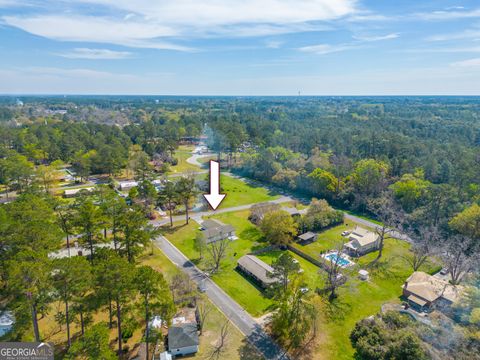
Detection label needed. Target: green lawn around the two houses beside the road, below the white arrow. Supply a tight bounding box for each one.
[161,211,272,316]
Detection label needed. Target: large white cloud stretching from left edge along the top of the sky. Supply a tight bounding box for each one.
[0,0,357,51]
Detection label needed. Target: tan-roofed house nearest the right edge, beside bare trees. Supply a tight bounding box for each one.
[402,271,462,311]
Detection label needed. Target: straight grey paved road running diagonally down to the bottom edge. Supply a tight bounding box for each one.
[154,236,288,360]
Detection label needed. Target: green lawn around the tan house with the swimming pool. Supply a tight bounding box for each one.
[260,223,440,359]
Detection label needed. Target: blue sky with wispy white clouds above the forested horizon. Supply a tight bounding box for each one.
[0,0,480,95]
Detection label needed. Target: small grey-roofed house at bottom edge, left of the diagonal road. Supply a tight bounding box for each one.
[168,323,200,356]
